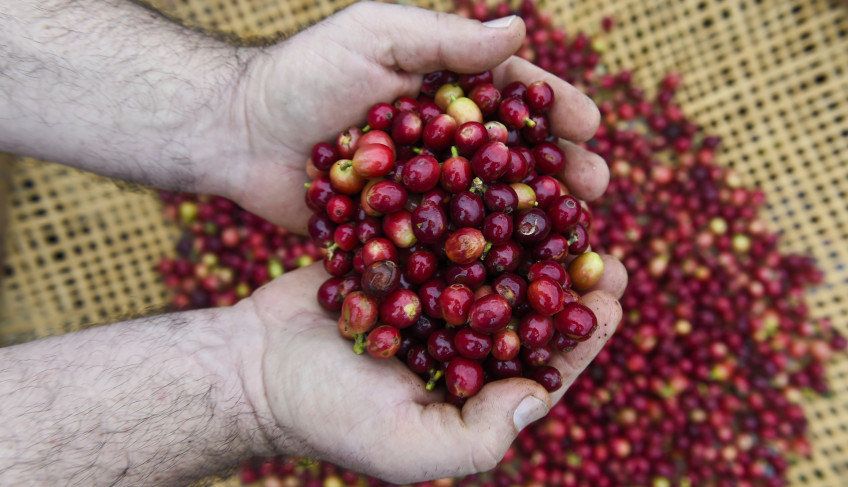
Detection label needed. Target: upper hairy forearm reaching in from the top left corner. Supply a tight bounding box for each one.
[0,0,243,192]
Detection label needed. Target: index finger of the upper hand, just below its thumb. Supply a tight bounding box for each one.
[494,56,601,142]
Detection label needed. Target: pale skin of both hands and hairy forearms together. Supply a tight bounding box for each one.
[0,0,627,485]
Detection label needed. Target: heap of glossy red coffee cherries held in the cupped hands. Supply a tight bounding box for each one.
[306,71,603,405]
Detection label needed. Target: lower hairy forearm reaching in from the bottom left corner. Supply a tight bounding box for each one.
[0,308,266,486]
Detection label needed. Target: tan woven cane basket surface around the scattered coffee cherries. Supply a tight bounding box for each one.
[0,0,848,487]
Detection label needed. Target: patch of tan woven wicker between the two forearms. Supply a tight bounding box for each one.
[0,159,176,345]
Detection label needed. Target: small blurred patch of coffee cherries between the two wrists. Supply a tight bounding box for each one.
[156,191,324,310]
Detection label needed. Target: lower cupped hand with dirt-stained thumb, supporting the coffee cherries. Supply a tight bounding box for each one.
[237,169,627,483]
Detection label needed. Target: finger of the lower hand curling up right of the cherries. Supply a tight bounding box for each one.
[551,291,622,402]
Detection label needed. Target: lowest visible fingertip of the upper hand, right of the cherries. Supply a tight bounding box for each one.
[559,140,610,201]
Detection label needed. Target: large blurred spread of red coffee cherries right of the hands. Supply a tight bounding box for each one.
[157,0,846,487]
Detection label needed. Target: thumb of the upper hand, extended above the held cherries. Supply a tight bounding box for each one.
[335,2,525,73]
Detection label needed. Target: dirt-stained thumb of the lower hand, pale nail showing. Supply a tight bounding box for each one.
[381,378,552,484]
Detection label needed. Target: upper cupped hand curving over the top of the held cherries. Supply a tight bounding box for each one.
[215,2,606,233]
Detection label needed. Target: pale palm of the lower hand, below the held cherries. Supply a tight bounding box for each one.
[245,265,490,475]
